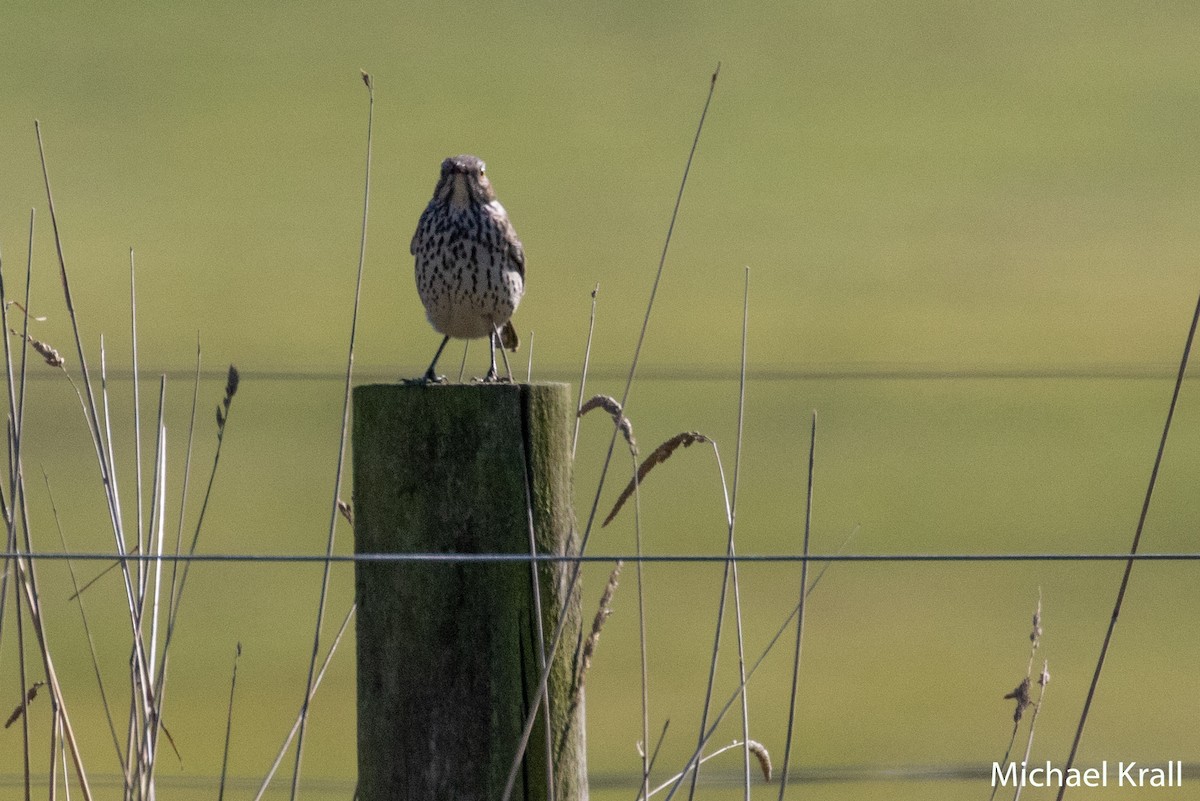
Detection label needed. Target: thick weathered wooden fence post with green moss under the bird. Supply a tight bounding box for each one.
[354,384,587,801]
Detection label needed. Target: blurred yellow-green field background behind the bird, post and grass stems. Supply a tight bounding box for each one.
[0,2,1200,799]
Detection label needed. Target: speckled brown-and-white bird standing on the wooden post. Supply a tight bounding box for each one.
[409,155,524,384]
